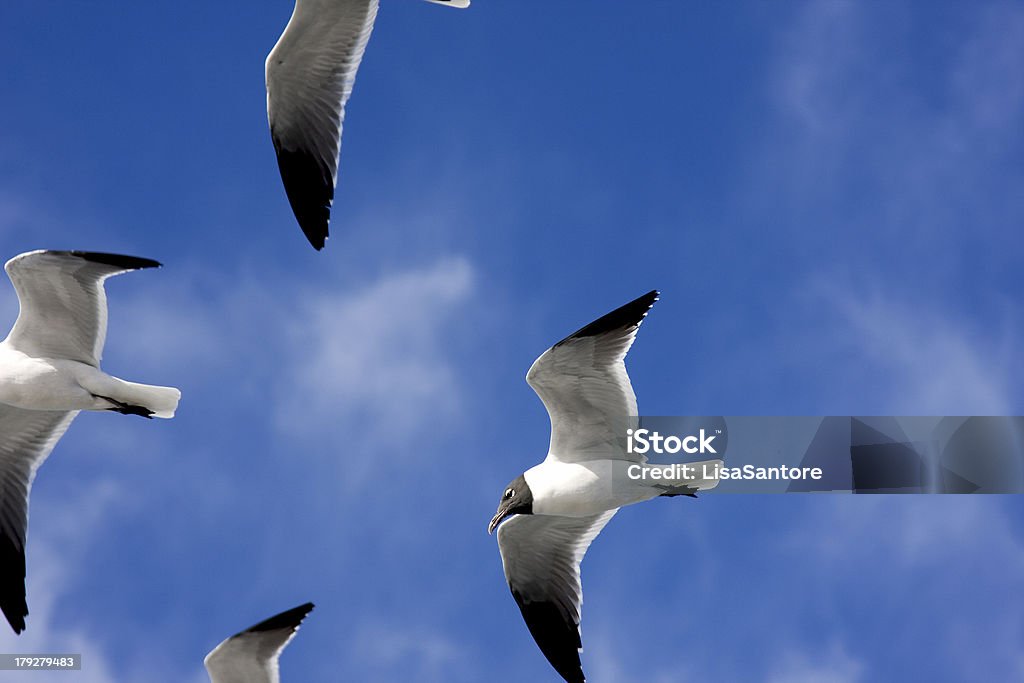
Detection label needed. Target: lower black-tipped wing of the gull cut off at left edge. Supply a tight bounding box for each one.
[0,403,78,633]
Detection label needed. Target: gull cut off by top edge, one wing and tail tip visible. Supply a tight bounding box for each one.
[266,0,469,251]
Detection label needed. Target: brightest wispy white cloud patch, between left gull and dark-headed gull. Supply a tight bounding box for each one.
[278,258,473,438]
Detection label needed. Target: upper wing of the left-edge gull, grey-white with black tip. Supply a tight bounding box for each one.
[4,250,160,367]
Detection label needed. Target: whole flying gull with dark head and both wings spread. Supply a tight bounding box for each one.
[487,291,720,683]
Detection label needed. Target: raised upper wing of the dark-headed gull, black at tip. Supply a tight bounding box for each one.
[526,291,658,462]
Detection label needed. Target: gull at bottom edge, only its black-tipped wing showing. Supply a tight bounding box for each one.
[203,602,313,683]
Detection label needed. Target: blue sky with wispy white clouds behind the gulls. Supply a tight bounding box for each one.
[0,0,1024,683]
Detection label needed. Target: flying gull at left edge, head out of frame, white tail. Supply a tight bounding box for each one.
[0,251,181,633]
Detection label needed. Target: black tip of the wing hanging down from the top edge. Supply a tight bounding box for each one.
[273,143,334,251]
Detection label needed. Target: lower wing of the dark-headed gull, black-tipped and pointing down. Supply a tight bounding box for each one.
[498,510,616,683]
